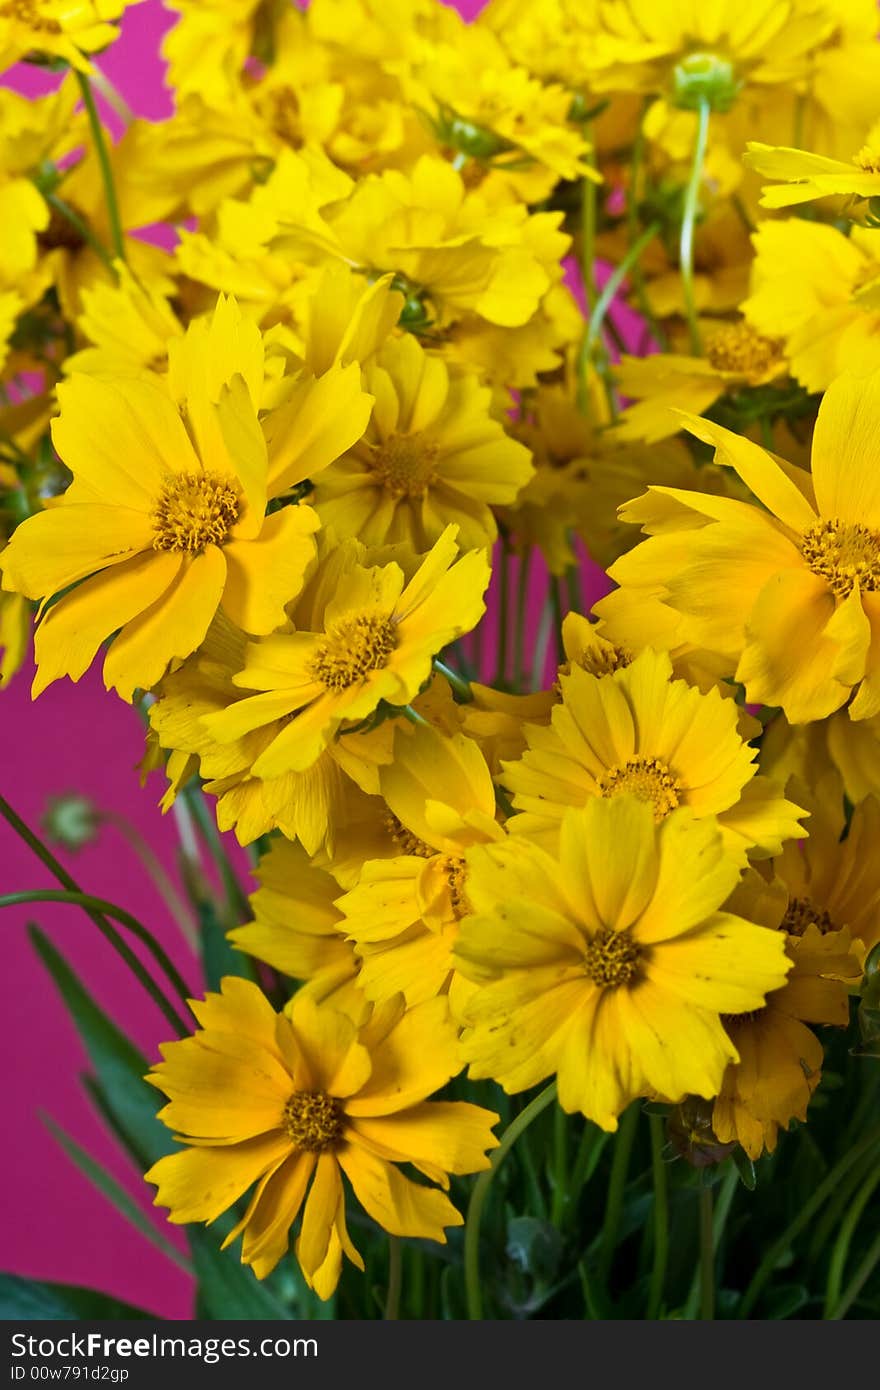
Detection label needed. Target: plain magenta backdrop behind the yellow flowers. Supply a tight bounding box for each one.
[0,0,611,1318]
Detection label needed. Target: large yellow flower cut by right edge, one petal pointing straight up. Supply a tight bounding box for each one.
[596,373,880,723]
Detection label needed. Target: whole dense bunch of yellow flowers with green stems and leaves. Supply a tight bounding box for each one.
[0,0,880,1319]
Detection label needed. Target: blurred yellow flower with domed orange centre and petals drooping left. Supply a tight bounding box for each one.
[612,320,787,443]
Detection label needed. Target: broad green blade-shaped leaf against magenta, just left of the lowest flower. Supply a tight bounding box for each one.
[29,926,174,1168]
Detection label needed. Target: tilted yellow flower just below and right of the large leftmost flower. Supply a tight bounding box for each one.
[204,527,489,777]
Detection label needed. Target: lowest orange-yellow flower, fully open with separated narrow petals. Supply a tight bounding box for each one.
[146,977,498,1298]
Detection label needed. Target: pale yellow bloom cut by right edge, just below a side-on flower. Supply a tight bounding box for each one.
[742,217,880,391]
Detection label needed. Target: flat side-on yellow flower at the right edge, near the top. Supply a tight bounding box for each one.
[744,122,880,207]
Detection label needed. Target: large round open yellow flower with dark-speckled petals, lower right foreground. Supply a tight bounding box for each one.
[456,796,791,1130]
